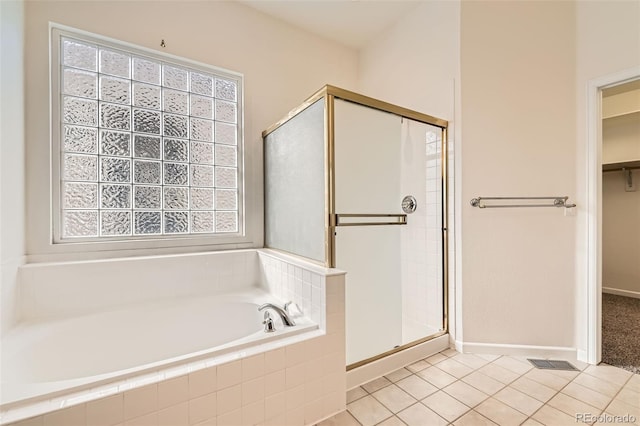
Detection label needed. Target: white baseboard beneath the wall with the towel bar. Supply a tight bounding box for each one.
[456,341,578,361]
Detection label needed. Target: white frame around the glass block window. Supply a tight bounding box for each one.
[49,23,254,252]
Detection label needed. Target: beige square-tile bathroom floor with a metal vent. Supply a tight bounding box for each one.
[318,349,640,426]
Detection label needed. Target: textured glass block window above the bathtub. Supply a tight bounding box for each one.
[54,32,242,241]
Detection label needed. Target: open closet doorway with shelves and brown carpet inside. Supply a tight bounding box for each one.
[600,79,640,373]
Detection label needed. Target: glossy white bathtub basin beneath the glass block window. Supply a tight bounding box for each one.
[2,289,317,405]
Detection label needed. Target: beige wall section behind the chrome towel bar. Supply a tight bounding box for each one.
[460,2,576,348]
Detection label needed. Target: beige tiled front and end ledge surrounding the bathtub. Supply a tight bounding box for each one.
[2,250,346,426]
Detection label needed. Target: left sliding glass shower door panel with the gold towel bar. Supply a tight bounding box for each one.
[334,100,402,365]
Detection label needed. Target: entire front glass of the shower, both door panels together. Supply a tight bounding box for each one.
[334,100,444,365]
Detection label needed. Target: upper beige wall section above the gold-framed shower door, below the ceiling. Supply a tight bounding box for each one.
[358,2,460,128]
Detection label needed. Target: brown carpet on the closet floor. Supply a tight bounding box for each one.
[602,293,640,374]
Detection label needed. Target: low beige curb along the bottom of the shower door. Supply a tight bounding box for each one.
[347,334,449,389]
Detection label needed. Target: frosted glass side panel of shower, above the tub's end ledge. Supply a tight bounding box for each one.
[264,99,325,263]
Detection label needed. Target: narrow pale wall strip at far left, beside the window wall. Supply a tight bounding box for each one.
[0,1,25,338]
